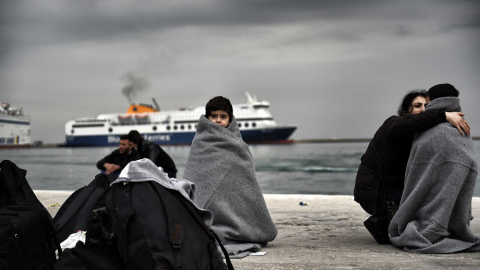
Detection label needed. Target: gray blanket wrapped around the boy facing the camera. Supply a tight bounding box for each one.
[184,115,277,258]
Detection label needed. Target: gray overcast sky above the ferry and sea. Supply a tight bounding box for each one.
[0,0,480,143]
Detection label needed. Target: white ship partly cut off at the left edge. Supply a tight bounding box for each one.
[0,102,30,148]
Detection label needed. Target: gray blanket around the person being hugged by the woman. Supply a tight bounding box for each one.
[389,97,480,253]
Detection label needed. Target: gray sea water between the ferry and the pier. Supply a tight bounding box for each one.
[0,141,480,197]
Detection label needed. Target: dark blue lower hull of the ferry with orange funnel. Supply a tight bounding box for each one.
[65,127,296,147]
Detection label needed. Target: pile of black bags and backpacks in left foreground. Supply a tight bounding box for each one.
[0,161,233,270]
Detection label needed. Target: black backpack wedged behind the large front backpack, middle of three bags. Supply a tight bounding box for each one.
[54,174,125,270]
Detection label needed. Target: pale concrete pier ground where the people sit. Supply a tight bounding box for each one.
[35,190,480,270]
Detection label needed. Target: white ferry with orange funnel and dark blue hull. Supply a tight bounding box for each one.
[65,93,297,146]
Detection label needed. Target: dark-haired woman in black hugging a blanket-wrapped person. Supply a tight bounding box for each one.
[353,90,470,244]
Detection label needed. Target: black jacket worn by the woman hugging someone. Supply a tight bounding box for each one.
[353,109,446,213]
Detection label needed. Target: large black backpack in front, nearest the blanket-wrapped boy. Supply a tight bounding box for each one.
[105,181,233,270]
